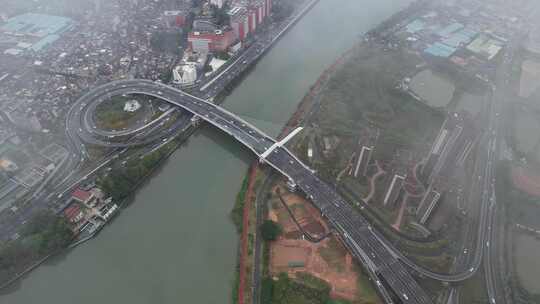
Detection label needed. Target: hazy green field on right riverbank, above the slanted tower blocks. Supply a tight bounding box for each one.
[298,45,444,184]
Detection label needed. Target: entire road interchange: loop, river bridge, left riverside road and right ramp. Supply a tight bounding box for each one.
[1,1,520,304]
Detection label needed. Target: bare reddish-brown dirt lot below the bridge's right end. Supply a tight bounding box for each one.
[269,185,375,303]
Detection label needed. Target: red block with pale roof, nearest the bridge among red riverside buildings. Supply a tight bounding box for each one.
[188,29,235,53]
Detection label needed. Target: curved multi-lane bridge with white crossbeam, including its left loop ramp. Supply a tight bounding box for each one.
[66,80,464,304]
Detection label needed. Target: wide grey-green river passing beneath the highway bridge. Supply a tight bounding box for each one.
[0,0,411,304]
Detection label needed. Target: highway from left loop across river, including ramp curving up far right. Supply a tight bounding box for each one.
[67,75,524,303]
